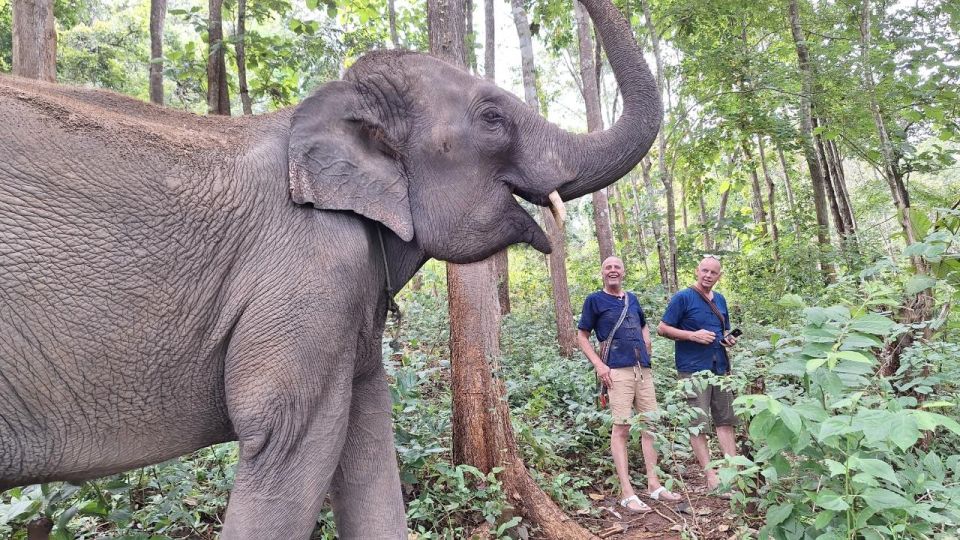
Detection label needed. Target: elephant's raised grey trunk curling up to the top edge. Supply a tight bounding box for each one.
[557,0,663,200]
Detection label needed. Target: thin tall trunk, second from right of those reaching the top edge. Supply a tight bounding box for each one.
[789,0,836,283]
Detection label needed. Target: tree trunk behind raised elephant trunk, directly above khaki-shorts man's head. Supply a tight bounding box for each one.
[573,2,613,260]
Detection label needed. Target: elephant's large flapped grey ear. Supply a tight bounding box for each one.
[288,81,413,242]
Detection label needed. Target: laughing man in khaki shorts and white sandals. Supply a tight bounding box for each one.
[577,257,680,512]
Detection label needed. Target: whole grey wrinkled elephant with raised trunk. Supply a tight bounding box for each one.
[0,0,661,538]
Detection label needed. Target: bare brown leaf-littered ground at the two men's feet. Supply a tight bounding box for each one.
[573,467,755,540]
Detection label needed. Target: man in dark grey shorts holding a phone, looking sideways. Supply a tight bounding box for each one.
[657,255,737,496]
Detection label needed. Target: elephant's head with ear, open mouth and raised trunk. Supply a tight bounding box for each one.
[289,0,663,262]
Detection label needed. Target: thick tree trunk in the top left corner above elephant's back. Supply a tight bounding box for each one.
[11,0,57,82]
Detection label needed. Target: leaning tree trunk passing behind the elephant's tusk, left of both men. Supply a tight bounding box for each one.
[510,0,577,358]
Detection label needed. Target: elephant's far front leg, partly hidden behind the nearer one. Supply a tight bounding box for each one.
[331,366,407,539]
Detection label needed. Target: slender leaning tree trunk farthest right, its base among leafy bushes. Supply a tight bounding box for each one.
[860,0,933,376]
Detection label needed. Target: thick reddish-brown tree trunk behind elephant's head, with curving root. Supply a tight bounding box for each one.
[444,0,594,539]
